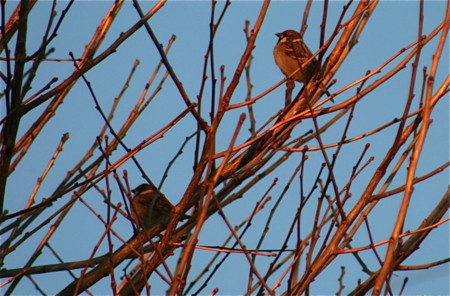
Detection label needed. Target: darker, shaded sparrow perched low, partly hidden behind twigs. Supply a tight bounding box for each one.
[131,183,189,229]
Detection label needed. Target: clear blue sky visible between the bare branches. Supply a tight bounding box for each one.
[1,1,450,295]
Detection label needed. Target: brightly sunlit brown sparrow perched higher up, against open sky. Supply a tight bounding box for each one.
[273,30,330,95]
